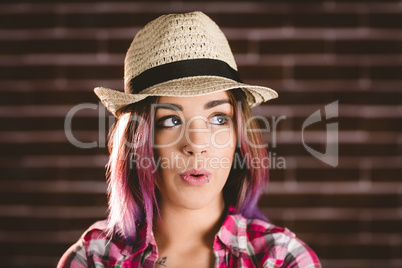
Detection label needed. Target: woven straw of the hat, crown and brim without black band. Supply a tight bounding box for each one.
[95,12,278,116]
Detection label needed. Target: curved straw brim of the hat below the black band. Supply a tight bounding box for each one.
[94,76,278,116]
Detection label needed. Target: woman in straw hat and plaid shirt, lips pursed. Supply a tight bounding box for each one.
[58,12,321,267]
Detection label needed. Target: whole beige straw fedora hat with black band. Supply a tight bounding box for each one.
[94,11,278,116]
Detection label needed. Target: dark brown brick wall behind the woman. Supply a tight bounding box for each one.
[0,0,402,268]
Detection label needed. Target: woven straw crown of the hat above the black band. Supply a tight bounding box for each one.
[124,12,237,88]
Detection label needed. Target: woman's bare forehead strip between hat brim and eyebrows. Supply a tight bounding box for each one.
[158,91,229,106]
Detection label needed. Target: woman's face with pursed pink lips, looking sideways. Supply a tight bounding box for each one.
[154,92,236,209]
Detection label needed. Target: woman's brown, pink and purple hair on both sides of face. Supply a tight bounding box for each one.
[107,89,268,239]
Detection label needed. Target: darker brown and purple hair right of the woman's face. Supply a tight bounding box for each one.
[223,89,269,220]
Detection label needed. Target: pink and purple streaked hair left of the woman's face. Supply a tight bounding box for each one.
[107,98,158,238]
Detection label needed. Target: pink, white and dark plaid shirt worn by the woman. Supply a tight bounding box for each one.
[57,210,321,268]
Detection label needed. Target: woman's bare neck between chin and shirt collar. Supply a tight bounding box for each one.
[154,197,225,248]
